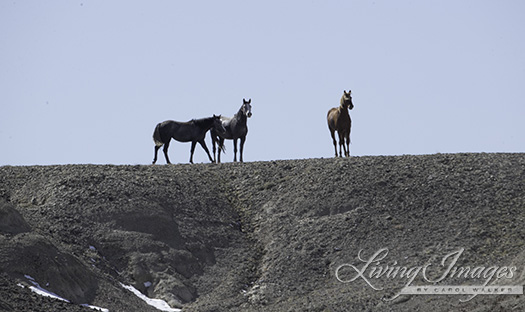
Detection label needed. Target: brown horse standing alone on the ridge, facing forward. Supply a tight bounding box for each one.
[326,90,354,157]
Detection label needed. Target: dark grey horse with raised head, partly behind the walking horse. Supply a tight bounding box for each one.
[210,99,252,163]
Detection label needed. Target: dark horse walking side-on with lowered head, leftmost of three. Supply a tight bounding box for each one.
[153,115,224,164]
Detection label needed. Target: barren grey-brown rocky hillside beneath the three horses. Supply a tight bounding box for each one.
[0,154,525,311]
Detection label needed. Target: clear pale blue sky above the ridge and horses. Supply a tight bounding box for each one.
[0,0,525,165]
